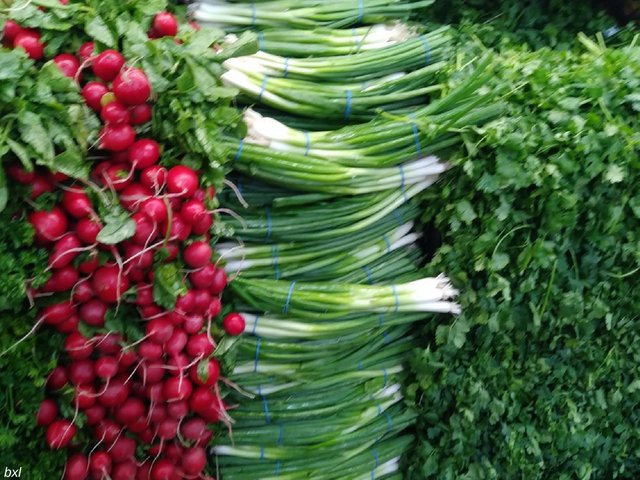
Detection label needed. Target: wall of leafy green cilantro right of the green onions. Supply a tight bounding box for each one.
[406,5,640,480]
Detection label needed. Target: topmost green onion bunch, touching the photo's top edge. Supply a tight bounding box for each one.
[189,0,434,30]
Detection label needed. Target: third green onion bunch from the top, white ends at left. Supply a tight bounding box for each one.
[223,27,450,82]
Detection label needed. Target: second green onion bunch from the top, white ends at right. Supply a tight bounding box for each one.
[244,22,418,57]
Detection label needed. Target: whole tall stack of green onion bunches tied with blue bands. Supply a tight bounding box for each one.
[192,1,499,480]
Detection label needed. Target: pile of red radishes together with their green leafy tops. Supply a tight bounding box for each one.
[0,2,252,480]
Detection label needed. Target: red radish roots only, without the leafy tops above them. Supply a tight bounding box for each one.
[4,7,245,480]
